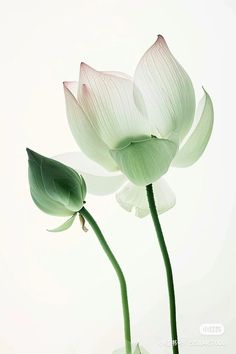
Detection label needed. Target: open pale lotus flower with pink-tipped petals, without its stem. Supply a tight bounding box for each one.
[56,35,214,217]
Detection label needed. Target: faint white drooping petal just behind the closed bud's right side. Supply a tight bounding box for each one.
[54,152,126,195]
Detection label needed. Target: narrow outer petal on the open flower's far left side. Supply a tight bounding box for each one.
[64,82,117,171]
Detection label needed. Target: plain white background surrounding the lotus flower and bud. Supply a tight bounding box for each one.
[0,0,236,354]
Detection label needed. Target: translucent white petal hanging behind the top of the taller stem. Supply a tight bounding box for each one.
[116,178,176,218]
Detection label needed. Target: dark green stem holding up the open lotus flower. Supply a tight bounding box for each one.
[146,184,179,354]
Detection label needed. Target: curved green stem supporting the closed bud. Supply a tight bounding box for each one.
[79,207,132,354]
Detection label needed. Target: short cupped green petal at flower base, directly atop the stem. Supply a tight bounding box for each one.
[110,137,177,186]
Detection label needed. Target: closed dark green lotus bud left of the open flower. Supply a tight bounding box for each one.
[27,149,86,217]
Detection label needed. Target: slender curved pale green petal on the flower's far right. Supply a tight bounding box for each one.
[172,91,214,167]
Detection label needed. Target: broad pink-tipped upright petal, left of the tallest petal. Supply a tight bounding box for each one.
[78,63,150,148]
